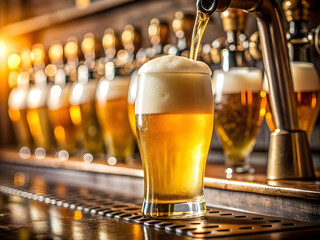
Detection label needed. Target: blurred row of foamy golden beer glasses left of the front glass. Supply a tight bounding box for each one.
[8,30,138,161]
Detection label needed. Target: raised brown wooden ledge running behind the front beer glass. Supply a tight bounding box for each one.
[0,149,320,200]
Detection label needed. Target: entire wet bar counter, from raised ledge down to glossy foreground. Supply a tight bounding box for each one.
[0,149,320,239]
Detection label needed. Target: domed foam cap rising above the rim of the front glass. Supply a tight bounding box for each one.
[139,55,212,75]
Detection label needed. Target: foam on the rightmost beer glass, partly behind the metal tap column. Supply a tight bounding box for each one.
[263,62,320,92]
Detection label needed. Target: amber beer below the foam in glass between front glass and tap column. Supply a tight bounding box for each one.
[215,91,264,164]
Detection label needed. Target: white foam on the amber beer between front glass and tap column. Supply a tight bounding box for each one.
[213,68,262,94]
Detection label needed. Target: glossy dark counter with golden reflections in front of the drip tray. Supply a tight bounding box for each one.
[0,195,162,240]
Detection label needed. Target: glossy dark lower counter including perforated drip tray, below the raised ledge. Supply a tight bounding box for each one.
[0,164,320,240]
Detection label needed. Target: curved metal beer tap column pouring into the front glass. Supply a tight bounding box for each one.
[197,0,314,180]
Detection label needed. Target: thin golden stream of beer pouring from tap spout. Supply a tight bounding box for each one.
[189,11,210,60]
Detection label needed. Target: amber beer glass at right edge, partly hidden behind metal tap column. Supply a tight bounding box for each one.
[263,62,320,138]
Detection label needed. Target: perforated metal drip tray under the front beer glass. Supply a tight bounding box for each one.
[0,183,320,238]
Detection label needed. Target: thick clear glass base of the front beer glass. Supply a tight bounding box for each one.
[142,201,207,219]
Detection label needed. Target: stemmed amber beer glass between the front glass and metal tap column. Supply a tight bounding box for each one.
[213,67,265,174]
